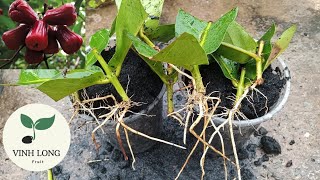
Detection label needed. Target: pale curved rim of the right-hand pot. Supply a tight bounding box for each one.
[212,58,291,127]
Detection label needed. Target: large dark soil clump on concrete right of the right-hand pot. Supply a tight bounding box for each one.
[261,136,281,155]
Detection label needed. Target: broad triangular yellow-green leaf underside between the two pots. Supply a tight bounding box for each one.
[151,33,209,67]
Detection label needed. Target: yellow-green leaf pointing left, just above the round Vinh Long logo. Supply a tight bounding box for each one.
[37,66,105,101]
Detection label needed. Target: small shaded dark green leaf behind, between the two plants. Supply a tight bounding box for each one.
[146,24,175,42]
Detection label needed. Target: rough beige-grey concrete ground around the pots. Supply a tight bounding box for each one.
[0,0,320,180]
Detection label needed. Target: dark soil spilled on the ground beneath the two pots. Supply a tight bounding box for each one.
[53,115,257,180]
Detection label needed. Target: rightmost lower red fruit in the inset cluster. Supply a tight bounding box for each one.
[57,26,82,54]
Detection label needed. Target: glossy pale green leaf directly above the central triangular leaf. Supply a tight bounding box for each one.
[175,9,208,41]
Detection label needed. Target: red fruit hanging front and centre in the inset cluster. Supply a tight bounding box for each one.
[26,20,48,51]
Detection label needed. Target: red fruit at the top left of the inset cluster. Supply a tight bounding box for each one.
[9,0,38,25]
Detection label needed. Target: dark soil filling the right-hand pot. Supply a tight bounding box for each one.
[200,63,286,119]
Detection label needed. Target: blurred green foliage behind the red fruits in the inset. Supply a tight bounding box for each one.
[0,0,86,69]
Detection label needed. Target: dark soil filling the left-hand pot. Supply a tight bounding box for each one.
[81,47,163,115]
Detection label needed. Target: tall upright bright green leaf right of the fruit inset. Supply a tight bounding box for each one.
[109,0,148,68]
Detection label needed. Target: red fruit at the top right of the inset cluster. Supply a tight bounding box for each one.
[43,4,77,26]
